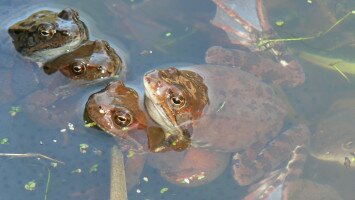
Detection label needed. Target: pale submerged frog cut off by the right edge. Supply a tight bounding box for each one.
[310,99,355,168]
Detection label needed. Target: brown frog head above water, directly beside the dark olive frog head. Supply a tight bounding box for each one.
[43,40,126,81]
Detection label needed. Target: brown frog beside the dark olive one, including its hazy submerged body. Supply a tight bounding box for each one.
[22,40,126,127]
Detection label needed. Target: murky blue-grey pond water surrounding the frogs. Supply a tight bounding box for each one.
[0,0,355,200]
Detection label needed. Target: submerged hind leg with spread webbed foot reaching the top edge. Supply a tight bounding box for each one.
[206,0,305,87]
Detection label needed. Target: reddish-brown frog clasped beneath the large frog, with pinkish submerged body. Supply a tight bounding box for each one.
[86,82,229,189]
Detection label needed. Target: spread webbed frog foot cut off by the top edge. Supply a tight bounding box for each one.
[211,0,292,66]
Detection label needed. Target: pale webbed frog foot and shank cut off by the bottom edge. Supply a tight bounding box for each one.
[244,145,308,200]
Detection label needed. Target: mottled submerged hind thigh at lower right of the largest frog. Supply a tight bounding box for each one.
[233,124,310,185]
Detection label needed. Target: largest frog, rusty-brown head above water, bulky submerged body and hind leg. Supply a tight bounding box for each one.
[143,64,310,197]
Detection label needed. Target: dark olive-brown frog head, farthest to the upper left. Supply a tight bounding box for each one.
[8,8,89,62]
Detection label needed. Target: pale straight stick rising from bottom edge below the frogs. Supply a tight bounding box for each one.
[110,146,128,200]
